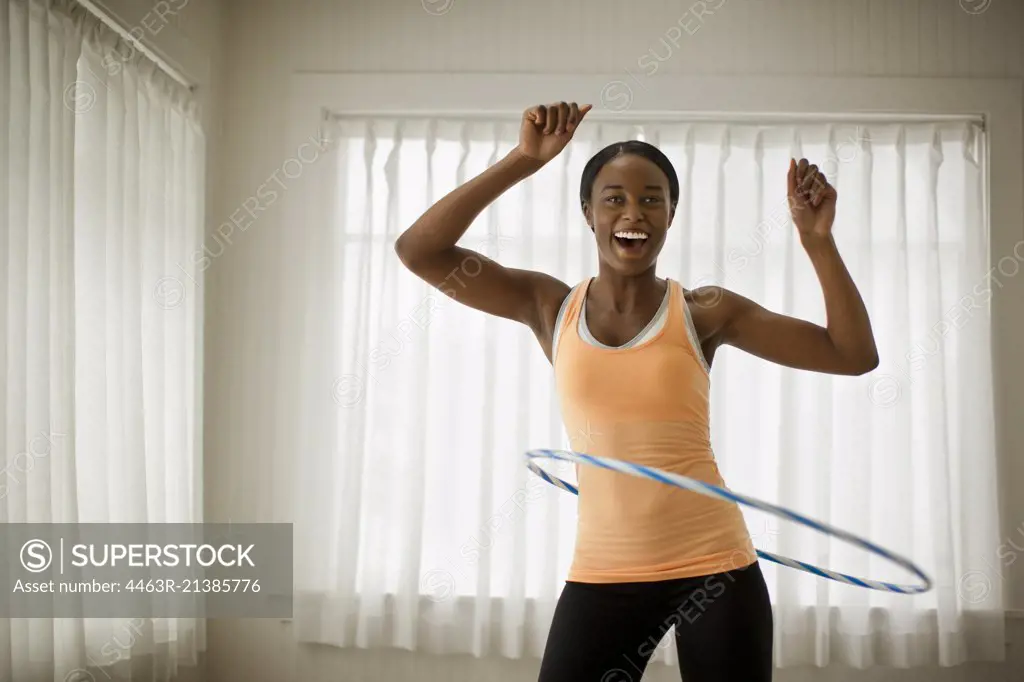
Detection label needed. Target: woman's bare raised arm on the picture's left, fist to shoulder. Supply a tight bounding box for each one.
[394,102,591,354]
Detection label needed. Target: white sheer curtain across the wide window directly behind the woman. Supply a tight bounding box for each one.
[290,117,1007,667]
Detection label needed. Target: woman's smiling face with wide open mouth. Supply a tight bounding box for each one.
[584,154,673,274]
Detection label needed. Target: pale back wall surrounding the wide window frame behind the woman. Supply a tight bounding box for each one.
[205,0,1024,682]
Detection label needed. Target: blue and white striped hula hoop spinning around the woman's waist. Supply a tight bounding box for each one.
[526,450,932,594]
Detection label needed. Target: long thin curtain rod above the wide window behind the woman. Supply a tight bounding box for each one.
[323,109,985,130]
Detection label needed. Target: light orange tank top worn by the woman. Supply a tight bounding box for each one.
[554,279,757,583]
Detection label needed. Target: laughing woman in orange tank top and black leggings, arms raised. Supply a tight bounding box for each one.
[395,102,878,682]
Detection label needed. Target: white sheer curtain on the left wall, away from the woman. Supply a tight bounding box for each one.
[0,0,205,682]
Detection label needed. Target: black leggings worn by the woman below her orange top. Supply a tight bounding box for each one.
[538,562,772,682]
